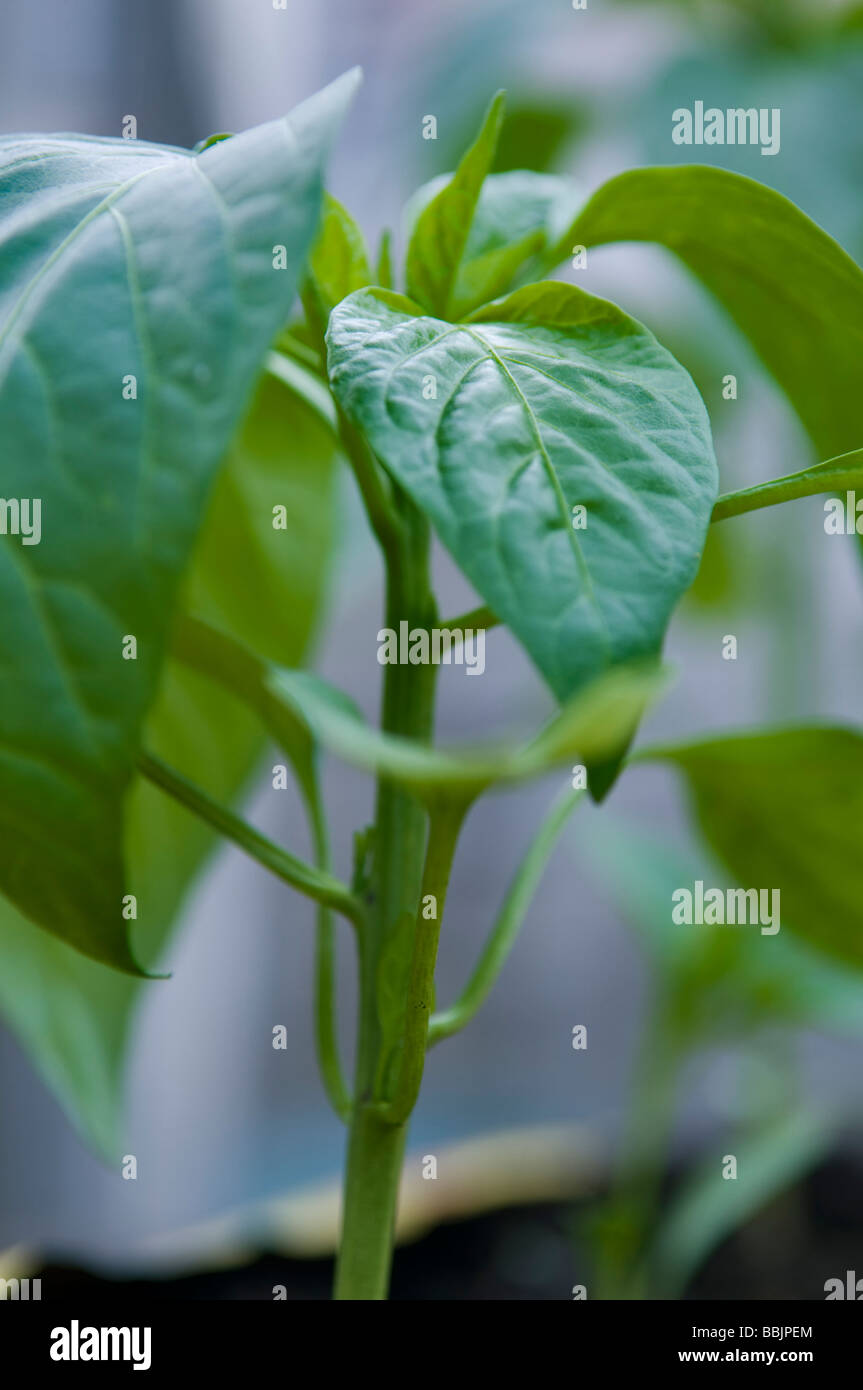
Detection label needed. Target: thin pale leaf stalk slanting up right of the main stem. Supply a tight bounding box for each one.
[428,788,585,1047]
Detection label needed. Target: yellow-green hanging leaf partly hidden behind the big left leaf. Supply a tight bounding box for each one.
[0,378,340,1154]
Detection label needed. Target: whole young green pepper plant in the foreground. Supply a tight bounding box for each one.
[0,74,863,1298]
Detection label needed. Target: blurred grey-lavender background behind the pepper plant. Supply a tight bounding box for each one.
[0,0,863,1298]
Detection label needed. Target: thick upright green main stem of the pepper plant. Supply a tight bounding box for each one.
[335,493,436,1300]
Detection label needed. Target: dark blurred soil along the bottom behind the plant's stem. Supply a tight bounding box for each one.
[30,1158,863,1302]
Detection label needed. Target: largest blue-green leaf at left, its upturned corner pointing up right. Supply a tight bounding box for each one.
[0,76,354,973]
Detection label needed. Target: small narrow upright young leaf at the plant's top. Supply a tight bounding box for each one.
[404,92,503,318]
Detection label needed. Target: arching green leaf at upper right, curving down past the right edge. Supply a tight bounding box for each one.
[559,164,863,456]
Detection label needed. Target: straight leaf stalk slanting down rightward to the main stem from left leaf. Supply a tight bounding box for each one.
[138,753,363,926]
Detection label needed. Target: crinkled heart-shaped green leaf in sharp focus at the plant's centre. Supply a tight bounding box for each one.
[328,281,716,699]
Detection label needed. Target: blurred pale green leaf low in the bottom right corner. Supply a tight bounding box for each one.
[648,1109,835,1298]
